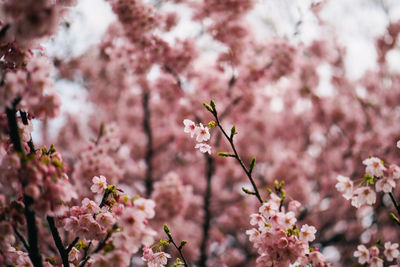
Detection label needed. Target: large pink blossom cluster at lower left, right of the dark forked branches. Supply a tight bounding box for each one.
[61,176,156,266]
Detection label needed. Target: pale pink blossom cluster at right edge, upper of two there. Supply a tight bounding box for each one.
[336,157,400,208]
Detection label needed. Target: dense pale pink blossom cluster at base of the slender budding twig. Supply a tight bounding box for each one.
[246,193,327,267]
